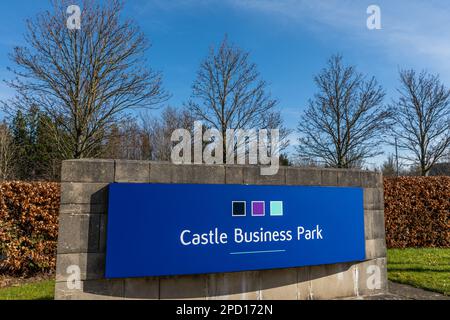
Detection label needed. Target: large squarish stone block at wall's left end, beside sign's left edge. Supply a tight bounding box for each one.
[58,214,101,253]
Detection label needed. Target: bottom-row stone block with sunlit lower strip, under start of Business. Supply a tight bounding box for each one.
[208,271,260,300]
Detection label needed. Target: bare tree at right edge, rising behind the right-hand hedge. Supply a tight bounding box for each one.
[392,70,450,176]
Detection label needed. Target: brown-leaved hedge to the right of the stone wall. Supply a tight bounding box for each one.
[384,177,450,248]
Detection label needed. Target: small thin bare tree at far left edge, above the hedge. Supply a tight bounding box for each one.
[0,123,17,181]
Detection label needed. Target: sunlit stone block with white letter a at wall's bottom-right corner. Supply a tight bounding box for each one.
[356,258,388,296]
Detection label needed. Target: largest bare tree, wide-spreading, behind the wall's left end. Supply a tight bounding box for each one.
[4,0,167,158]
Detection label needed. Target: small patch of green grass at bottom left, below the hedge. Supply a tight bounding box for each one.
[0,280,55,300]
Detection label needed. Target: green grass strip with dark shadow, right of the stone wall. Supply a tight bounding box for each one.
[388,248,450,295]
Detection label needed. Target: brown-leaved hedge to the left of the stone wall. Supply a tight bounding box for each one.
[0,182,60,276]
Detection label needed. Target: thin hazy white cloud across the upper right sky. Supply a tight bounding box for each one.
[229,0,450,80]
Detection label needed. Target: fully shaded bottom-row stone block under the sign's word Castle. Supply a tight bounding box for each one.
[159,275,207,300]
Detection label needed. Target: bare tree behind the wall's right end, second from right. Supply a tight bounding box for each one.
[297,55,389,168]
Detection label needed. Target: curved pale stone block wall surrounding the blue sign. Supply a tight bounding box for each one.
[55,160,387,300]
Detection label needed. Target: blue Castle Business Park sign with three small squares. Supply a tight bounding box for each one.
[106,183,365,278]
